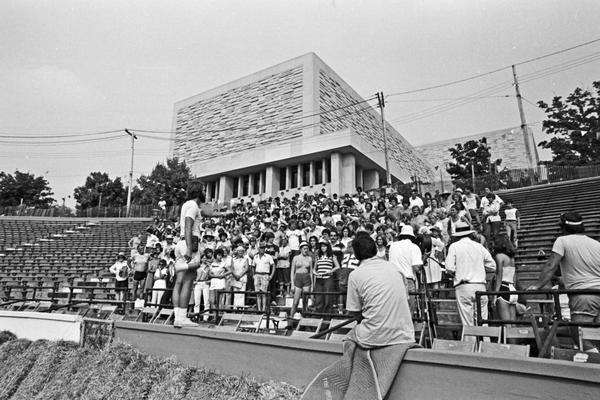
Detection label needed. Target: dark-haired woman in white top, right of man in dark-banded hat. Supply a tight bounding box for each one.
[494,235,518,328]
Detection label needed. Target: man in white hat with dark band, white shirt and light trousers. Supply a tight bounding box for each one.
[446,221,496,326]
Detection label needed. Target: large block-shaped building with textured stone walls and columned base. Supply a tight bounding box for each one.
[173,53,433,202]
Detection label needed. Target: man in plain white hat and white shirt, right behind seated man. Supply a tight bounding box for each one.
[389,225,423,314]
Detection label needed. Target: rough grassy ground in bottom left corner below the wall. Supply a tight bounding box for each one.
[0,332,300,400]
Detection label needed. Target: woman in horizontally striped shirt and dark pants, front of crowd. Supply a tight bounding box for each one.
[314,239,340,313]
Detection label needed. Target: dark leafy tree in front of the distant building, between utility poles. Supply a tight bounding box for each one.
[446,137,502,180]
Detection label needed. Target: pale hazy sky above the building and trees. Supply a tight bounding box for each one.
[0,0,600,206]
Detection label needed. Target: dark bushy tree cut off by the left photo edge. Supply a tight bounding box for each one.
[0,171,54,208]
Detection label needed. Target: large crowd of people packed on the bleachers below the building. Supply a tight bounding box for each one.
[111,180,520,324]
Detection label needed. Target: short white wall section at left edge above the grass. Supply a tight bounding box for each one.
[0,310,81,342]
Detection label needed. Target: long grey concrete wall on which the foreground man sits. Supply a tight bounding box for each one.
[115,321,600,400]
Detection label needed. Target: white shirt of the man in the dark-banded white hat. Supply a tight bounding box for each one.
[446,238,496,286]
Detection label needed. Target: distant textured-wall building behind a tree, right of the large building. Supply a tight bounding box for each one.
[415,127,539,180]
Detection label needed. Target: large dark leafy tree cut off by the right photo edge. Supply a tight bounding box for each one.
[538,81,600,165]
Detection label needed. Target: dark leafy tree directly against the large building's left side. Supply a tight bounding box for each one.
[132,157,193,205]
